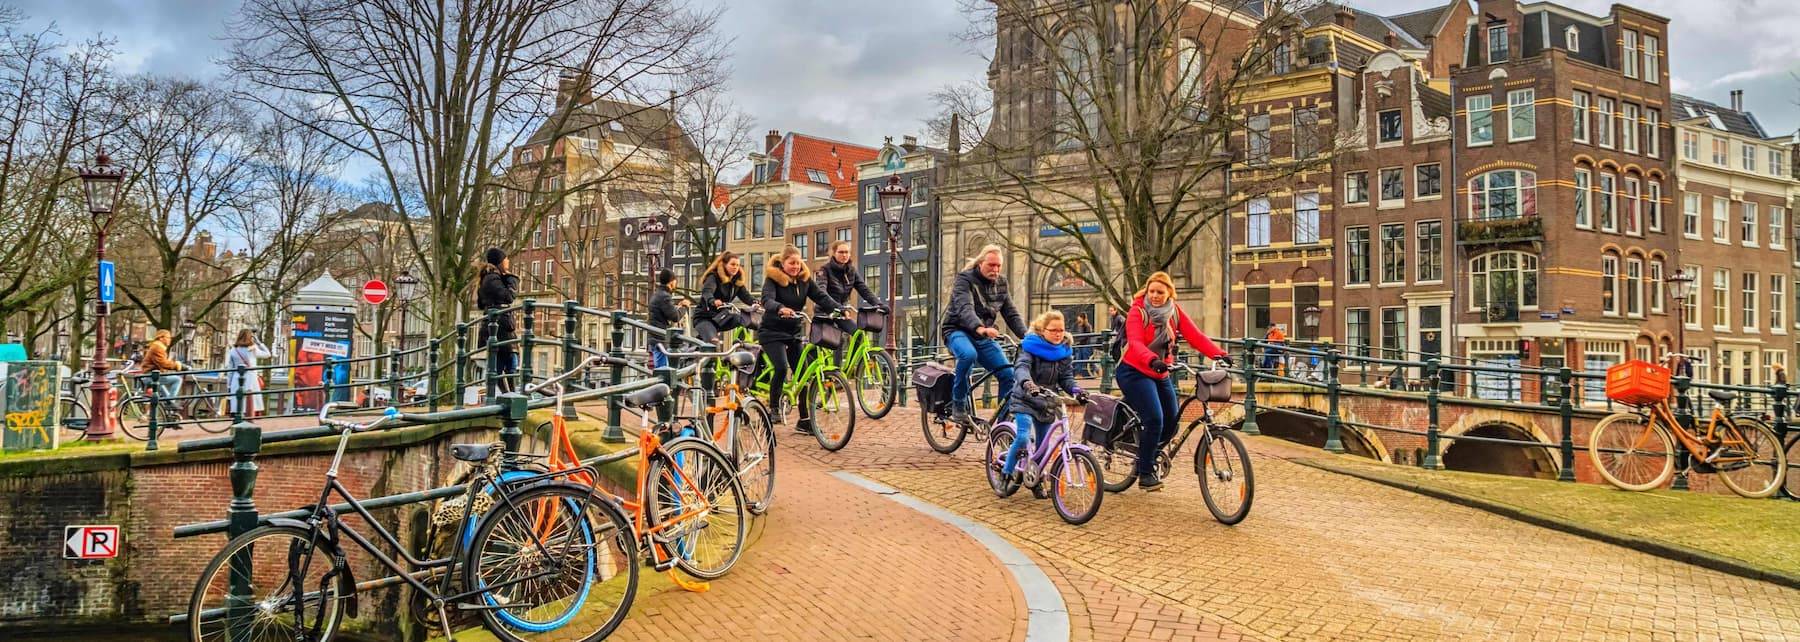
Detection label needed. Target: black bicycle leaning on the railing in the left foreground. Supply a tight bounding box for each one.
[184,403,637,642]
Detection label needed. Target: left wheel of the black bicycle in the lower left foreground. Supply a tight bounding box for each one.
[187,527,356,642]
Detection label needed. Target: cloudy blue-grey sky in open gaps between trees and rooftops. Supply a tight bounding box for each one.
[14,0,1800,152]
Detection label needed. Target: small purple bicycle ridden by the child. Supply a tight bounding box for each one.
[986,388,1105,525]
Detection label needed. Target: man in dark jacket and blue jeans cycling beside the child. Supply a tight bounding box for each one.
[943,245,1026,424]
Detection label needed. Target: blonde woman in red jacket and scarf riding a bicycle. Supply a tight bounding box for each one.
[1114,272,1229,491]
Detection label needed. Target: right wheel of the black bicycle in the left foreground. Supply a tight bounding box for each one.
[463,484,637,642]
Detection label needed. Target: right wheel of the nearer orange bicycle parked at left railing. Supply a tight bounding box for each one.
[643,439,751,579]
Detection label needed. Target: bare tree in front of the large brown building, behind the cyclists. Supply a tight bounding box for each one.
[927,0,1332,308]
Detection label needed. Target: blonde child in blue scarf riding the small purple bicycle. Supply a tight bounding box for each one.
[1001,311,1087,475]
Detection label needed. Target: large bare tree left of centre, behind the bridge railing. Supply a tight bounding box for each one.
[227,0,718,333]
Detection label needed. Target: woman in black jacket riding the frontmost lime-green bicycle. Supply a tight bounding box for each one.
[756,245,839,433]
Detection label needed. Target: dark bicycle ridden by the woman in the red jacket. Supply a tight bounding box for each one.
[1098,361,1256,525]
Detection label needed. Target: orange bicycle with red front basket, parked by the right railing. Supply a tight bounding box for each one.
[1588,361,1787,498]
